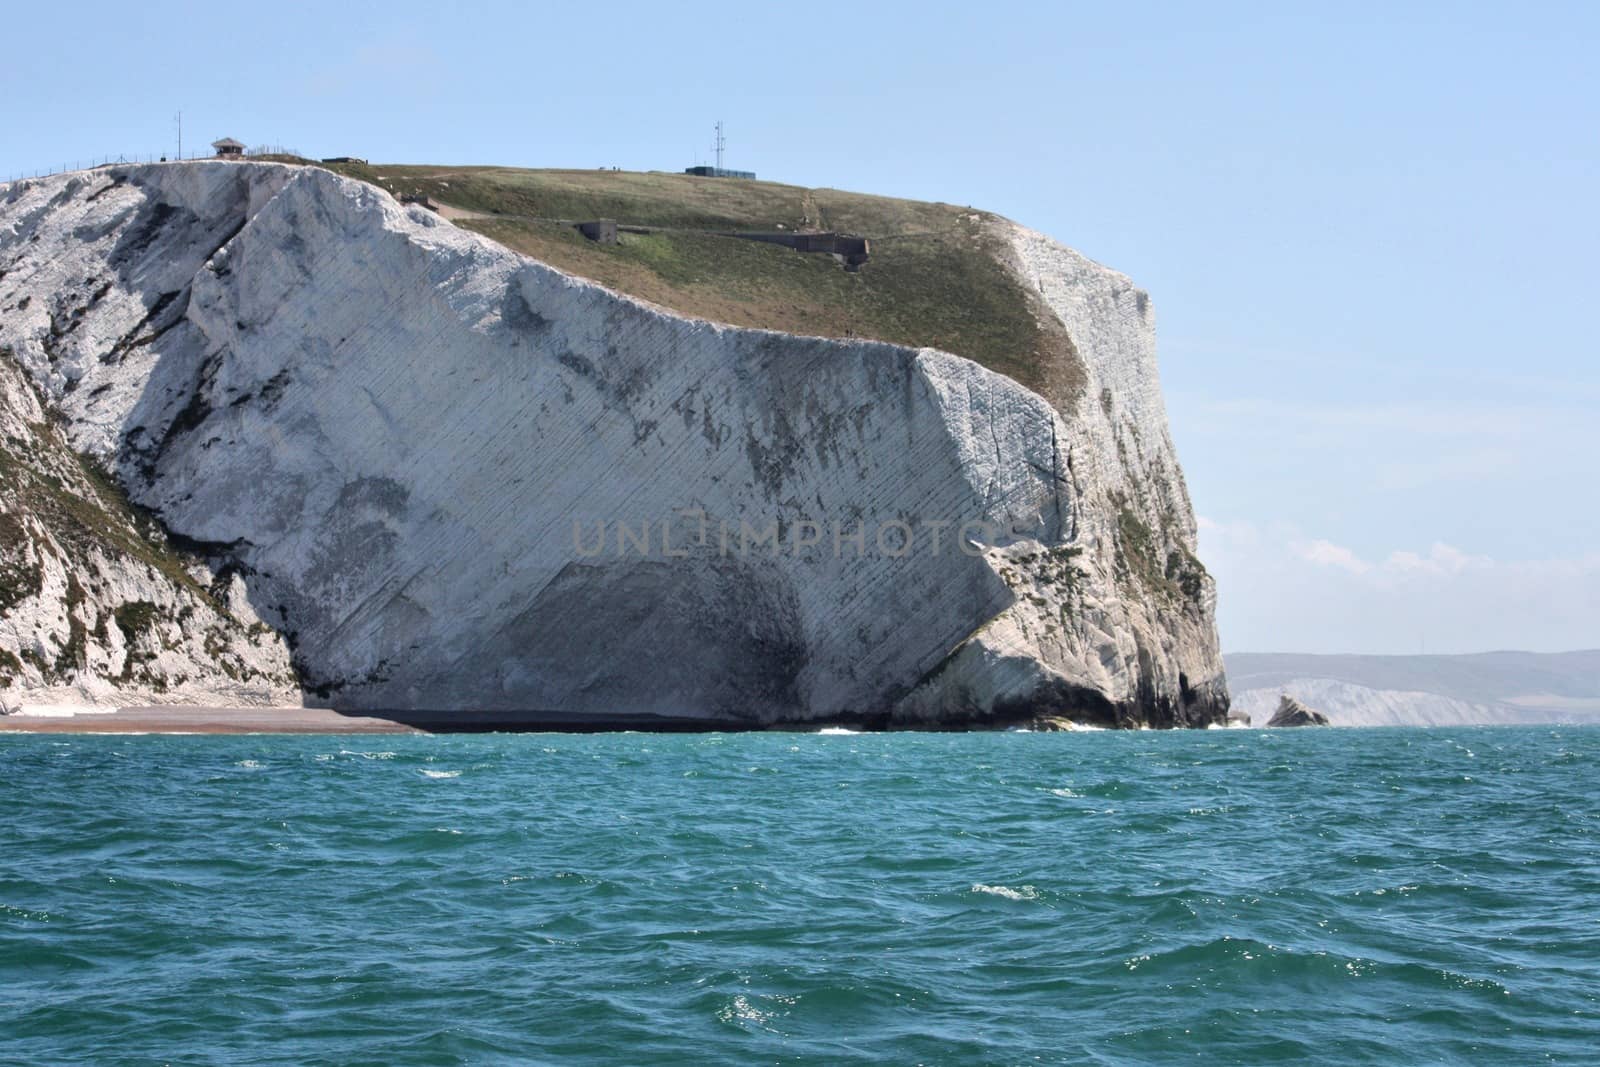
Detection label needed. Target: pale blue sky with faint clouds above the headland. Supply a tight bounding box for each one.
[0,0,1600,651]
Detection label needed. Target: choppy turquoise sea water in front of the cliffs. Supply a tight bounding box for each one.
[0,728,1600,1064]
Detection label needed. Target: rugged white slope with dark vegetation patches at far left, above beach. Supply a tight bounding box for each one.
[0,350,299,705]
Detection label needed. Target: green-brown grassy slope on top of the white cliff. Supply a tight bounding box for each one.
[315,163,1078,405]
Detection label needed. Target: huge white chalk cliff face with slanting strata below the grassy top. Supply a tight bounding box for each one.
[0,163,1227,725]
